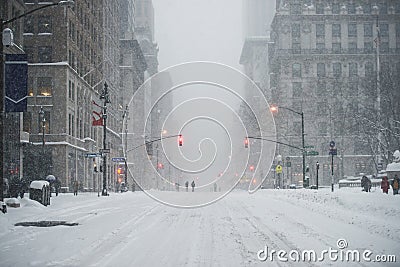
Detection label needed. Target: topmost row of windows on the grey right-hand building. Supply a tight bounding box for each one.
[290,0,400,15]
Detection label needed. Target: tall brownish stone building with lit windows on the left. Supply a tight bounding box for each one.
[19,0,147,193]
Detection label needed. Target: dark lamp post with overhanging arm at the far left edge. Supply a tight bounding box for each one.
[0,0,75,213]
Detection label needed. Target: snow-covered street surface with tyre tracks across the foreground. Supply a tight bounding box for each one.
[0,188,400,267]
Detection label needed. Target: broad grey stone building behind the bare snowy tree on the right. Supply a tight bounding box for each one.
[268,0,400,184]
